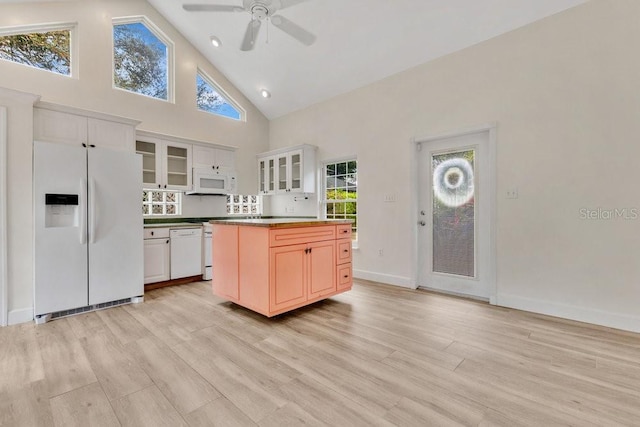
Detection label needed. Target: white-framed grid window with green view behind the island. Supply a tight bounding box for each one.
[323,159,358,241]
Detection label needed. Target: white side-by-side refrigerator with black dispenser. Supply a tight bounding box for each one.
[33,141,144,321]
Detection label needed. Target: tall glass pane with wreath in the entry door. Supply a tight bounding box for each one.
[431,150,476,277]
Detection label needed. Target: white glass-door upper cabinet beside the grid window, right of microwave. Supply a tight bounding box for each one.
[258,145,317,194]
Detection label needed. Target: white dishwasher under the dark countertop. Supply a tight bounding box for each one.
[169,227,202,280]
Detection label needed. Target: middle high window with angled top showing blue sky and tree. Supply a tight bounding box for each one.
[113,17,173,101]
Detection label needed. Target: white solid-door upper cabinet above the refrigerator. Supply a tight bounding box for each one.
[33,102,139,151]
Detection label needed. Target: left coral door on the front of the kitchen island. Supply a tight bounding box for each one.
[269,244,309,312]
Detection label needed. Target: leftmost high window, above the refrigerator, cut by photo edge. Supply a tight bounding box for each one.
[0,24,75,76]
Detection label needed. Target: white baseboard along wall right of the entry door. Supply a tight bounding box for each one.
[496,293,640,332]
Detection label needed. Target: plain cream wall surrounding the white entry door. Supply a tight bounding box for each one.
[270,0,640,331]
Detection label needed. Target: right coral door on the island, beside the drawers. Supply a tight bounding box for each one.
[307,240,336,300]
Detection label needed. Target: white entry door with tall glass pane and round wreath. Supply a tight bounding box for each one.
[416,129,495,300]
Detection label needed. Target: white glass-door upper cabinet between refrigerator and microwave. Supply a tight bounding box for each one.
[136,135,193,191]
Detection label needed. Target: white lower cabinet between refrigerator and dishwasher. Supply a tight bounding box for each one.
[144,228,171,285]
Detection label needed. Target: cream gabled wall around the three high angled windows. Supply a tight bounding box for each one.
[0,0,269,323]
